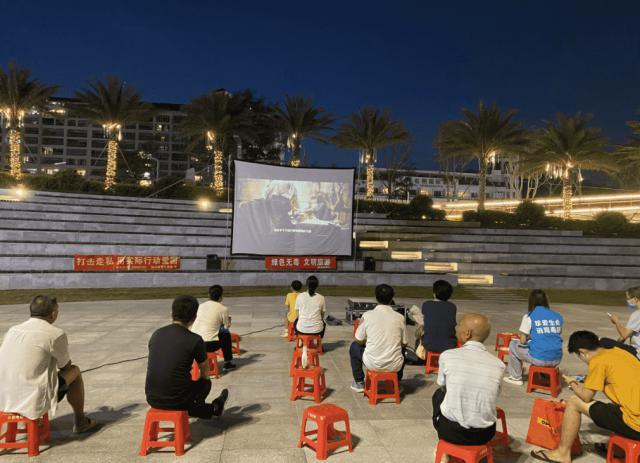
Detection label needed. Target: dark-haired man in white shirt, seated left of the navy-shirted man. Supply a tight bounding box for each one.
[349,285,407,392]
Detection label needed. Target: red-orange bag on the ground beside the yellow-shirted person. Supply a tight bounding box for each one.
[527,399,582,456]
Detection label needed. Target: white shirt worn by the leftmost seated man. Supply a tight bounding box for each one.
[0,318,69,420]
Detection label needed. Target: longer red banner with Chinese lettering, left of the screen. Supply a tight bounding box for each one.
[73,254,180,272]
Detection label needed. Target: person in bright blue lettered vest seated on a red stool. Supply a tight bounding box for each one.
[503,289,564,386]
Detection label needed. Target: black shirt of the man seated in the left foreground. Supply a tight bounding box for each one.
[145,324,207,409]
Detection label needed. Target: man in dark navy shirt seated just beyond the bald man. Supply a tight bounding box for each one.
[422,280,457,353]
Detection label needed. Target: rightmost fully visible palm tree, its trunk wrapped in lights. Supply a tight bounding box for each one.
[533,113,617,219]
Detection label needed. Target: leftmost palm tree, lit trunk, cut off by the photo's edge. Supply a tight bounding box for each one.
[0,63,59,180]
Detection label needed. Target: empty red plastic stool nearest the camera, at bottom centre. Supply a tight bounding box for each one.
[298,404,353,460]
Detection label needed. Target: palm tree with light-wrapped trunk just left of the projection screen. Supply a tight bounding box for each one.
[182,90,253,195]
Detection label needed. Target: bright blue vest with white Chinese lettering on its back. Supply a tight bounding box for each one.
[529,306,564,362]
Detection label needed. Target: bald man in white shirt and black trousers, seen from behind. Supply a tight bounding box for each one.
[433,313,504,452]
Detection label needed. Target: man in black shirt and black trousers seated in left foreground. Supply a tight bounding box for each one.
[145,296,229,419]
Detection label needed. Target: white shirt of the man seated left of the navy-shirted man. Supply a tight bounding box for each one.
[356,305,407,371]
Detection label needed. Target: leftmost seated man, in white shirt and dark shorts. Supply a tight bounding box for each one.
[0,295,96,433]
